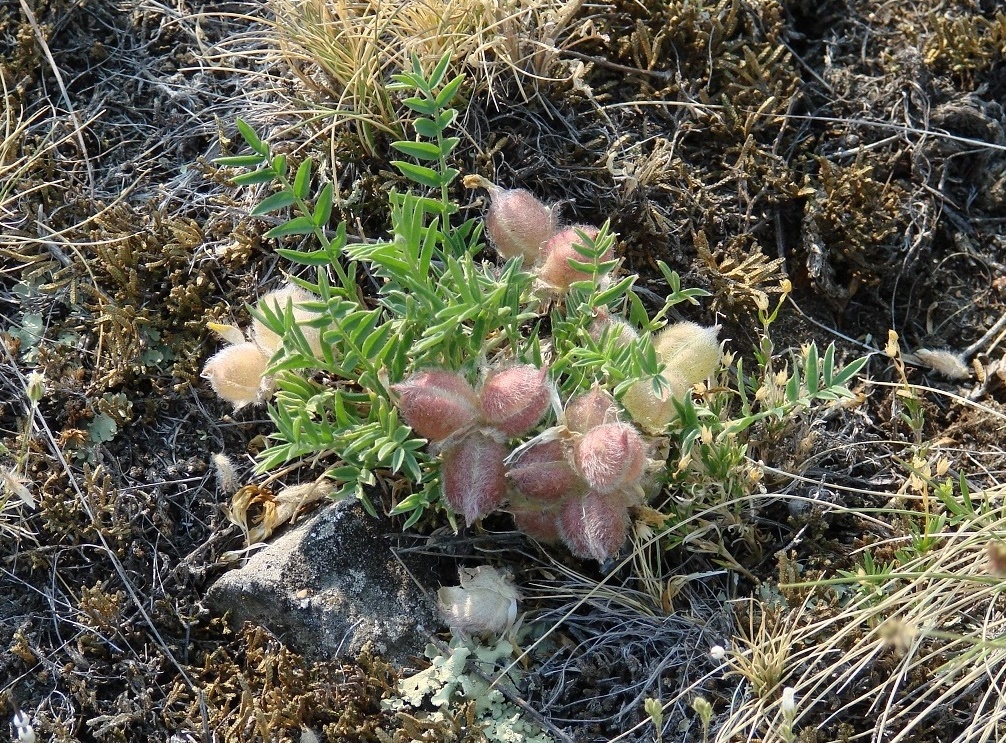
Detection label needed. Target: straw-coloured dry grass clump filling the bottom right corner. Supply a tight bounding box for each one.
[716,490,1006,743]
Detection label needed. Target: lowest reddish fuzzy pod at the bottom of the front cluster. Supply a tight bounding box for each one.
[558,493,629,562]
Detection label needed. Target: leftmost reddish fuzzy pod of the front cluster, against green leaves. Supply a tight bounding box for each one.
[391,370,479,442]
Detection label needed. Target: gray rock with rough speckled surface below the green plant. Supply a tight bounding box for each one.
[206,501,443,667]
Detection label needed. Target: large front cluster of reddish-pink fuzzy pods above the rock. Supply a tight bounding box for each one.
[392,364,647,561]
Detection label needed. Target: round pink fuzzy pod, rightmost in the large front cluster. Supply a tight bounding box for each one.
[573,423,646,493]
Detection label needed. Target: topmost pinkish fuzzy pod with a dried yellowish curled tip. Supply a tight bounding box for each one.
[486,186,558,265]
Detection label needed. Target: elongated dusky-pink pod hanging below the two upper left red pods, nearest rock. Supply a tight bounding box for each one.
[441,432,508,525]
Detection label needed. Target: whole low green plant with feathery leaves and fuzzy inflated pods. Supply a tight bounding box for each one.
[207,56,861,560]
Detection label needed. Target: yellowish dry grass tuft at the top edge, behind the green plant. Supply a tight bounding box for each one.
[271,0,583,144]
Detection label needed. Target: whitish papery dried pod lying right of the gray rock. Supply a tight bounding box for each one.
[437,565,517,634]
